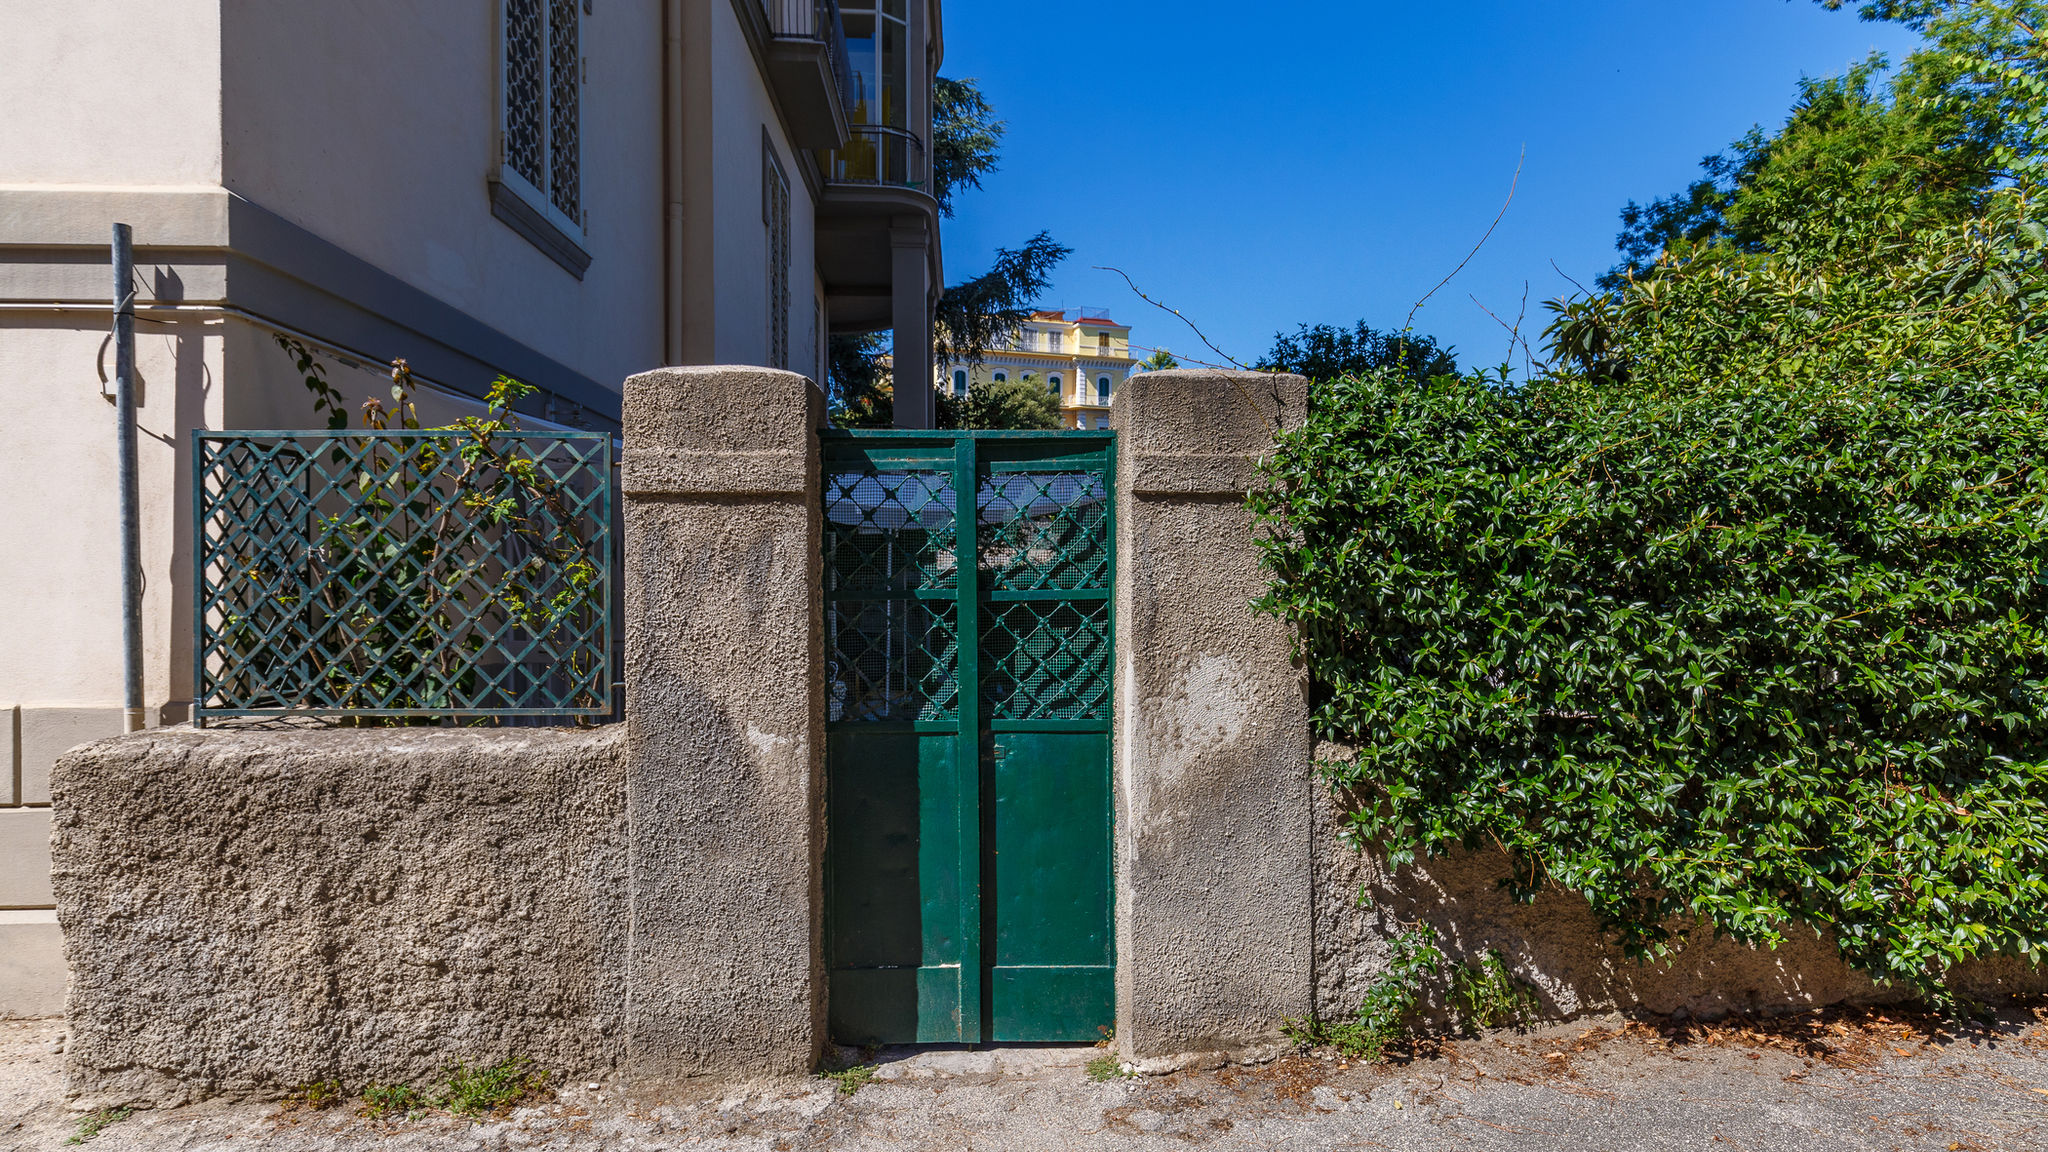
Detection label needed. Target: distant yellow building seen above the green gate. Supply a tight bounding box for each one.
[936,307,1137,428]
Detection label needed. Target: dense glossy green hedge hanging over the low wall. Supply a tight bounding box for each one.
[1253,357,2048,992]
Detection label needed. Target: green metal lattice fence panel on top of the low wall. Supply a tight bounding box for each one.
[193,430,612,724]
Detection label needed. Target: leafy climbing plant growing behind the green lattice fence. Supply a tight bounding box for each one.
[247,336,600,724]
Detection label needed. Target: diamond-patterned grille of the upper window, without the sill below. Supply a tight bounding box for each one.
[504,0,584,230]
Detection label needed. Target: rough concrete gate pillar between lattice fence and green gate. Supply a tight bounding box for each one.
[621,367,825,1086]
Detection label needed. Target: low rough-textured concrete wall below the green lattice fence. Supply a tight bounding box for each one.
[53,726,627,1107]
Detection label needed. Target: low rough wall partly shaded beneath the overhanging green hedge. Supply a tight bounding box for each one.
[1315,748,2048,1019]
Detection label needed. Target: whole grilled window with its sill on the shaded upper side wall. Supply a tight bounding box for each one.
[492,0,590,279]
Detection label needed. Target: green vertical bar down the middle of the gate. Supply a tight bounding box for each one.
[952,437,987,1043]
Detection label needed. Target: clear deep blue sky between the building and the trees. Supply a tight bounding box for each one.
[942,0,1913,367]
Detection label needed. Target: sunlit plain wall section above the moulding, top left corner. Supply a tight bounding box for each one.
[0,0,222,184]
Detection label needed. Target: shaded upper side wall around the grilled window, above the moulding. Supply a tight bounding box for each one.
[221,0,662,387]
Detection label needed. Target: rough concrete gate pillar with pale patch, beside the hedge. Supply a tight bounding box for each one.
[1110,371,1315,1070]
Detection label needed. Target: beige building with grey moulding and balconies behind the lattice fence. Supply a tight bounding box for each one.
[0,0,942,1015]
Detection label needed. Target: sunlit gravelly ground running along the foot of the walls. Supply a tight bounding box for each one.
[0,1009,2048,1152]
